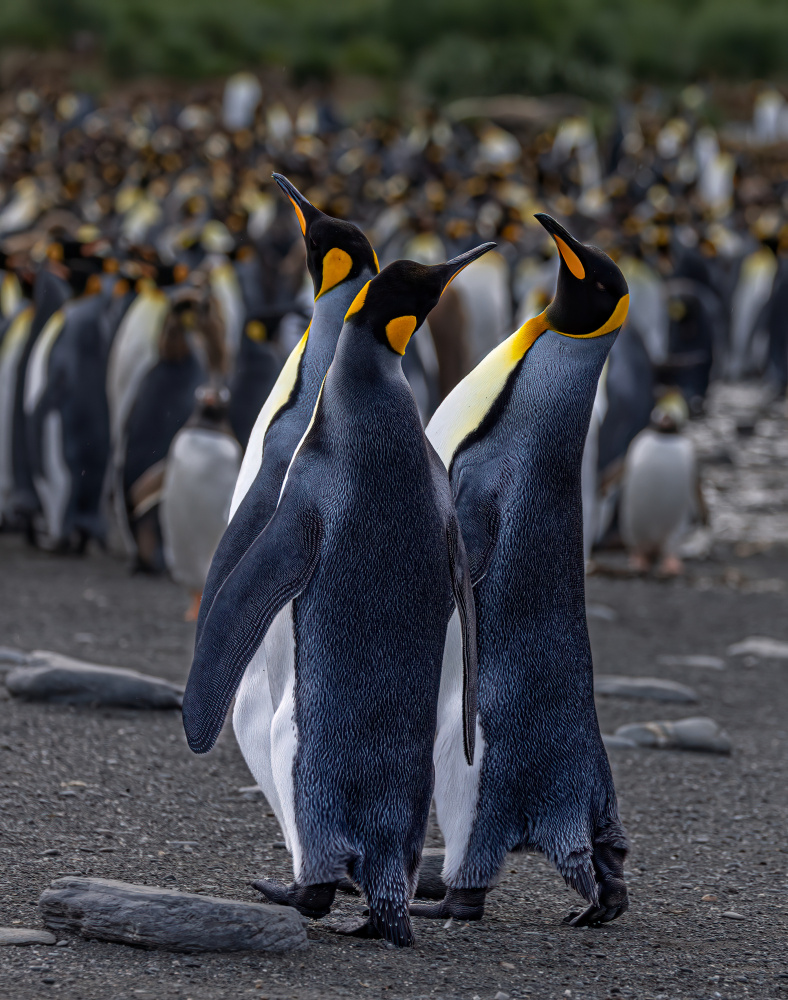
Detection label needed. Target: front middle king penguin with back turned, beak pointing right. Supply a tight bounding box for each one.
[183,244,492,945]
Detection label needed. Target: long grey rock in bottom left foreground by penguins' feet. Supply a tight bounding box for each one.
[38,877,306,952]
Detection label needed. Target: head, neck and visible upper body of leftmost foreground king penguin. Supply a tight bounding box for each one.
[197,174,380,639]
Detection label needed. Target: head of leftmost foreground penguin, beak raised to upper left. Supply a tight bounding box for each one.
[273,174,380,300]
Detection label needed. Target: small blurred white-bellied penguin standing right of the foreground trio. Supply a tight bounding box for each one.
[620,392,705,576]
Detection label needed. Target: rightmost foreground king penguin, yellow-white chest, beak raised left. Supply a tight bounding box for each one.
[411,215,628,924]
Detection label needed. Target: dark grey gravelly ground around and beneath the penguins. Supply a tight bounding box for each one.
[0,384,788,1000]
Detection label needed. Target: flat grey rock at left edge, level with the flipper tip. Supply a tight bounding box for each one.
[5,650,183,708]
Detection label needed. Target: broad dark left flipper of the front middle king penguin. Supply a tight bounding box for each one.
[183,489,323,753]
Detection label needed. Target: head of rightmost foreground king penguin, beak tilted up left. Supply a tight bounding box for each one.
[536,214,629,337]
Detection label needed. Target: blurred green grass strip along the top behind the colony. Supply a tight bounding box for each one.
[0,0,788,100]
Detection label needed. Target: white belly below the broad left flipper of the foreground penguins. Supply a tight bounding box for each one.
[233,601,302,879]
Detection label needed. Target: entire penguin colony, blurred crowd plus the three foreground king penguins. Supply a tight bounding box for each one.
[0,77,788,945]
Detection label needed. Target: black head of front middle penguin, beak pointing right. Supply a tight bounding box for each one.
[345,243,495,355]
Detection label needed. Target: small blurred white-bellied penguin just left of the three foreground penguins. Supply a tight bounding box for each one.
[161,386,241,621]
